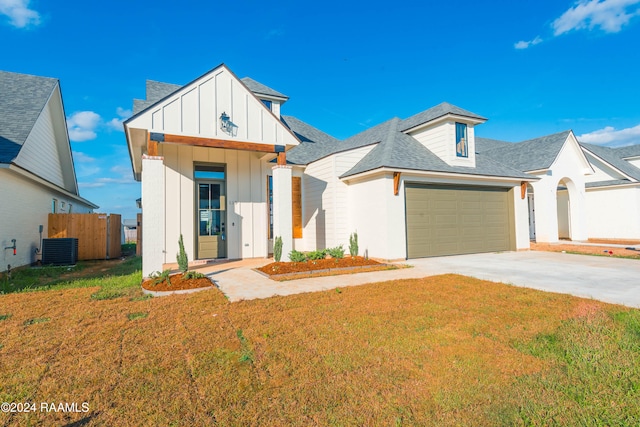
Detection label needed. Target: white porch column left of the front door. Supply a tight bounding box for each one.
[142,155,165,277]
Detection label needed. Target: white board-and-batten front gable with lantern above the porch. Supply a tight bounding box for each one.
[126,65,298,146]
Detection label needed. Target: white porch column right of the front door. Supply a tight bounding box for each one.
[273,165,293,261]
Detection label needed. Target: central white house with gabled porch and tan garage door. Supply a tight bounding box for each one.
[124,65,539,275]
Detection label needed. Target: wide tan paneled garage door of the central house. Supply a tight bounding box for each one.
[405,184,515,258]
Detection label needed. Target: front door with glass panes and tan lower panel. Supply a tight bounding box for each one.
[197,180,227,259]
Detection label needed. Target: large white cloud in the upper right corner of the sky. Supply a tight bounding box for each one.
[551,0,640,36]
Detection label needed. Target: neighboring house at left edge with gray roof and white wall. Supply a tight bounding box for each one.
[0,71,97,271]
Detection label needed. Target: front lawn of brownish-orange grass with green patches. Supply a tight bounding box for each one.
[0,275,640,426]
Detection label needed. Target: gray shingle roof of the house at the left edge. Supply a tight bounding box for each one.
[0,71,58,163]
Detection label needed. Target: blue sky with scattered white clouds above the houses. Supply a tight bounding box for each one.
[0,0,640,218]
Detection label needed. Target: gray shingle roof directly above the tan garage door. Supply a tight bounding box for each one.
[341,118,534,179]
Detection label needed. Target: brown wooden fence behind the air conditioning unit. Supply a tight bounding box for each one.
[48,214,122,260]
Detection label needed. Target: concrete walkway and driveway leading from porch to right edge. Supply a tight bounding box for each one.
[199,251,640,308]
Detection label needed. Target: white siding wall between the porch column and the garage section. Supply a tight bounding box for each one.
[299,145,375,251]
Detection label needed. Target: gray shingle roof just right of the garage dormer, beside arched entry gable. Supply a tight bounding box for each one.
[480,130,571,172]
